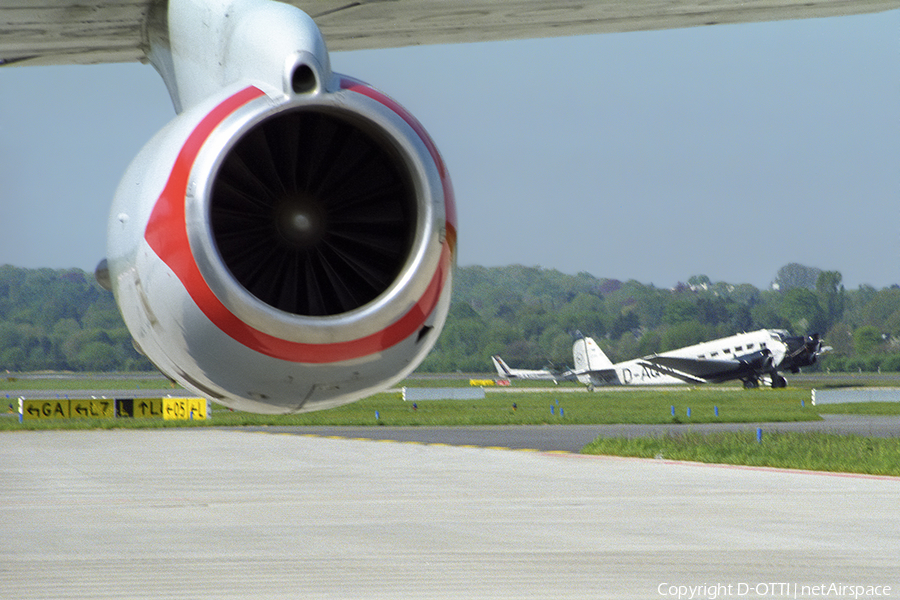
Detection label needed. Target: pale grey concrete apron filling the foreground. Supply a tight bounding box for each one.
[0,429,900,600]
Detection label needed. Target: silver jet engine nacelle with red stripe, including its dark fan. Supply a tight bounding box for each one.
[107,72,456,413]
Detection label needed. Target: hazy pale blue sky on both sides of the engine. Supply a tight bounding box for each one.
[0,11,900,287]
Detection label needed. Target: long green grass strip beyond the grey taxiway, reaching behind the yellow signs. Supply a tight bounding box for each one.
[0,388,820,430]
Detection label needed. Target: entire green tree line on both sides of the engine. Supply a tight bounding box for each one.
[0,264,900,372]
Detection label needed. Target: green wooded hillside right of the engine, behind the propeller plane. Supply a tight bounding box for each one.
[420,264,900,371]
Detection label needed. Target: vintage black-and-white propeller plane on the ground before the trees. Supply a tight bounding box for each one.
[572,329,830,389]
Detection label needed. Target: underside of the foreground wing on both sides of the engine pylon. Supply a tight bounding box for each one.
[0,0,900,65]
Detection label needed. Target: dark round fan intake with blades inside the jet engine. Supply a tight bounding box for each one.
[209,107,417,317]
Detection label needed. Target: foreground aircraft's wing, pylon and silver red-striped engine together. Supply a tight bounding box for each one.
[0,0,900,413]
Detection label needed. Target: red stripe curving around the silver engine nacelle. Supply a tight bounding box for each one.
[144,86,456,363]
